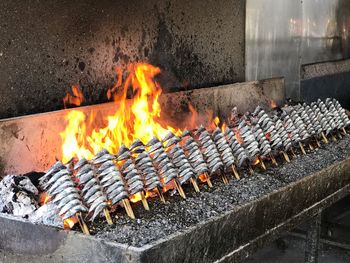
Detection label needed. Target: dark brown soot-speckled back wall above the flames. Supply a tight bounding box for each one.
[0,0,245,118]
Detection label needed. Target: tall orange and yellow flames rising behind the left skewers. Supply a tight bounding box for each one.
[60,63,181,162]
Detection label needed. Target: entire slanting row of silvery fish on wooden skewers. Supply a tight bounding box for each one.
[0,99,350,234]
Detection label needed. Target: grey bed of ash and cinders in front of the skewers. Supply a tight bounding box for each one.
[90,136,350,247]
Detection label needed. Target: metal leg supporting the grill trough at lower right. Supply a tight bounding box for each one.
[305,212,321,263]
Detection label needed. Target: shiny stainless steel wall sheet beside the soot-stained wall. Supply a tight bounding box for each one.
[246,0,350,99]
